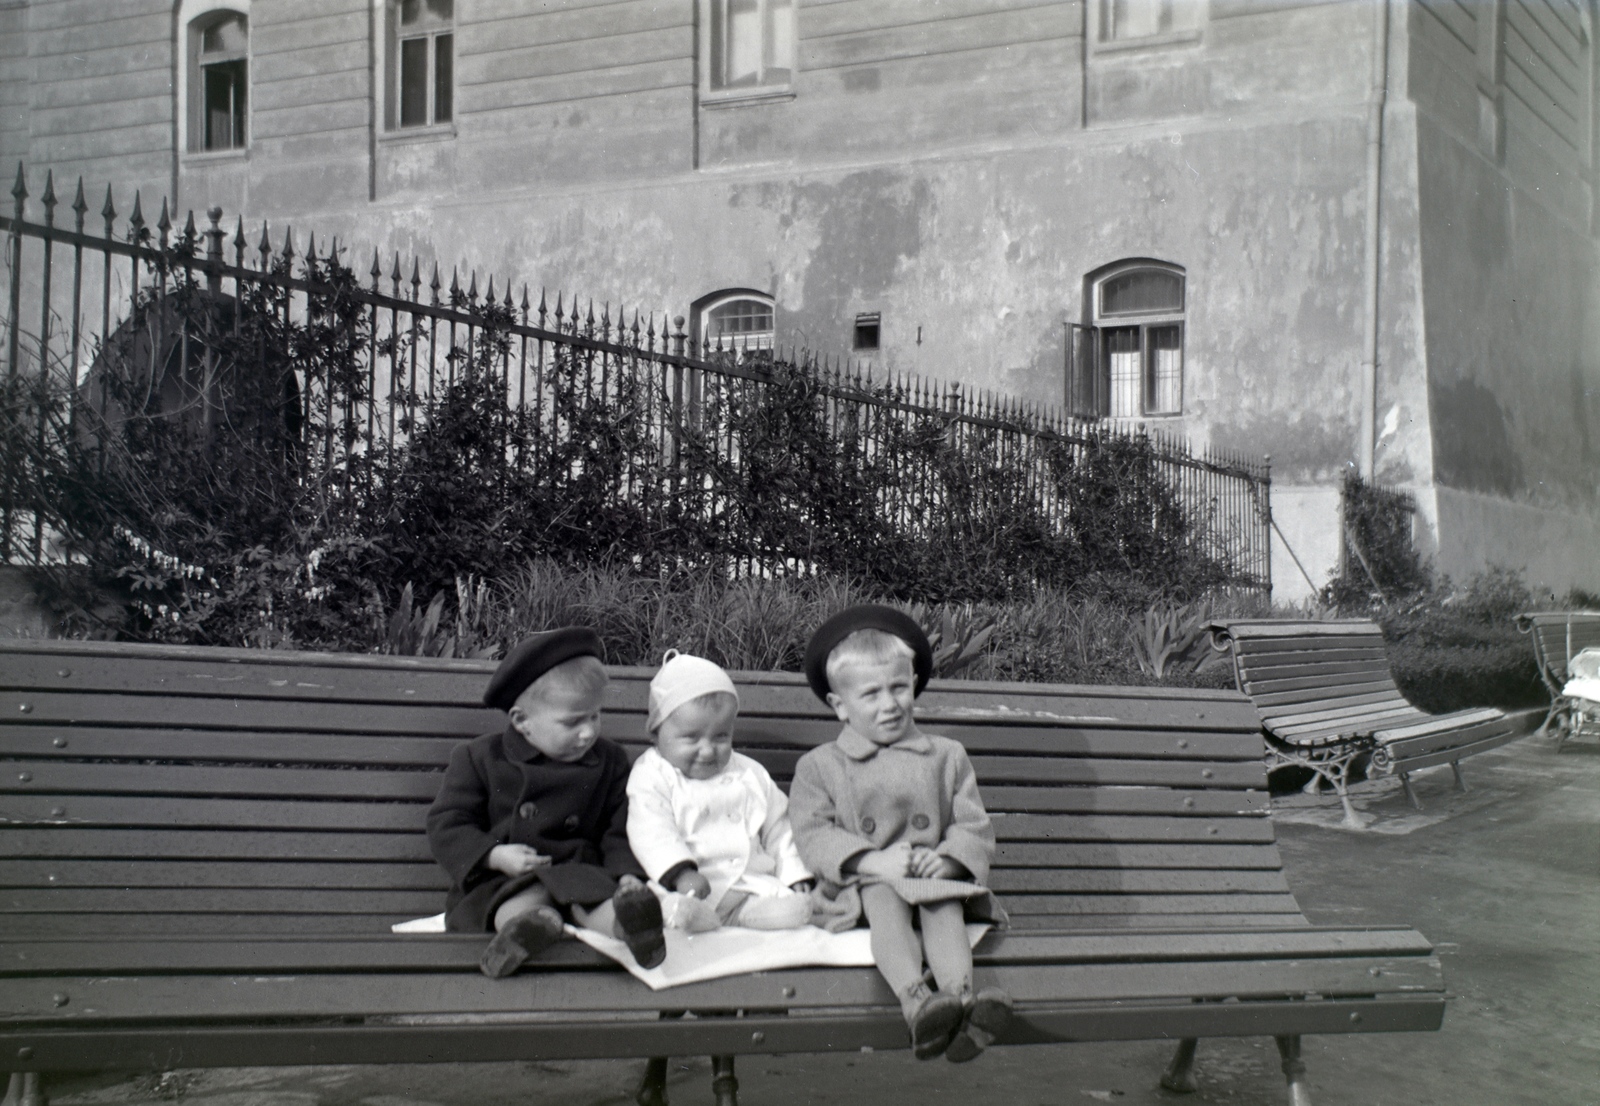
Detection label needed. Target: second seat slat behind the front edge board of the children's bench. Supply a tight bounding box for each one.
[0,927,1432,975]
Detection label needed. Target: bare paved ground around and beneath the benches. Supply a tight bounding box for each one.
[18,726,1600,1106]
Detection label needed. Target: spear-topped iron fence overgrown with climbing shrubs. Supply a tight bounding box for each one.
[0,170,1270,630]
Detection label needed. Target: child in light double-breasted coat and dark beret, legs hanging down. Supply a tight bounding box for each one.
[790,605,1011,1063]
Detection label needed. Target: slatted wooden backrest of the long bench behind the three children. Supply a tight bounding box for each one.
[0,642,1280,936]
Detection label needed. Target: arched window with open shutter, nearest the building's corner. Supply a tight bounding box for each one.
[1067,258,1187,419]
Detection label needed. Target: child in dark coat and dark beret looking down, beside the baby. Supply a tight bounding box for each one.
[427,627,666,978]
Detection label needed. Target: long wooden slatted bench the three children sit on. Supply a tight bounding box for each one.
[0,642,1445,1106]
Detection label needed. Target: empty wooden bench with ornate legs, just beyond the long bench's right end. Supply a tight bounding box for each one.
[1211,619,1522,826]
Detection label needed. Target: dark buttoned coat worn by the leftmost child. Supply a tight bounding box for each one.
[427,725,645,933]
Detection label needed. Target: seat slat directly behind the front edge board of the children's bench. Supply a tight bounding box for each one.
[0,957,1443,1024]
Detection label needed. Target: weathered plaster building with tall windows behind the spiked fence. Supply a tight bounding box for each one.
[0,0,1600,599]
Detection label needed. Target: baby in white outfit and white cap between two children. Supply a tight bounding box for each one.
[627,650,811,930]
